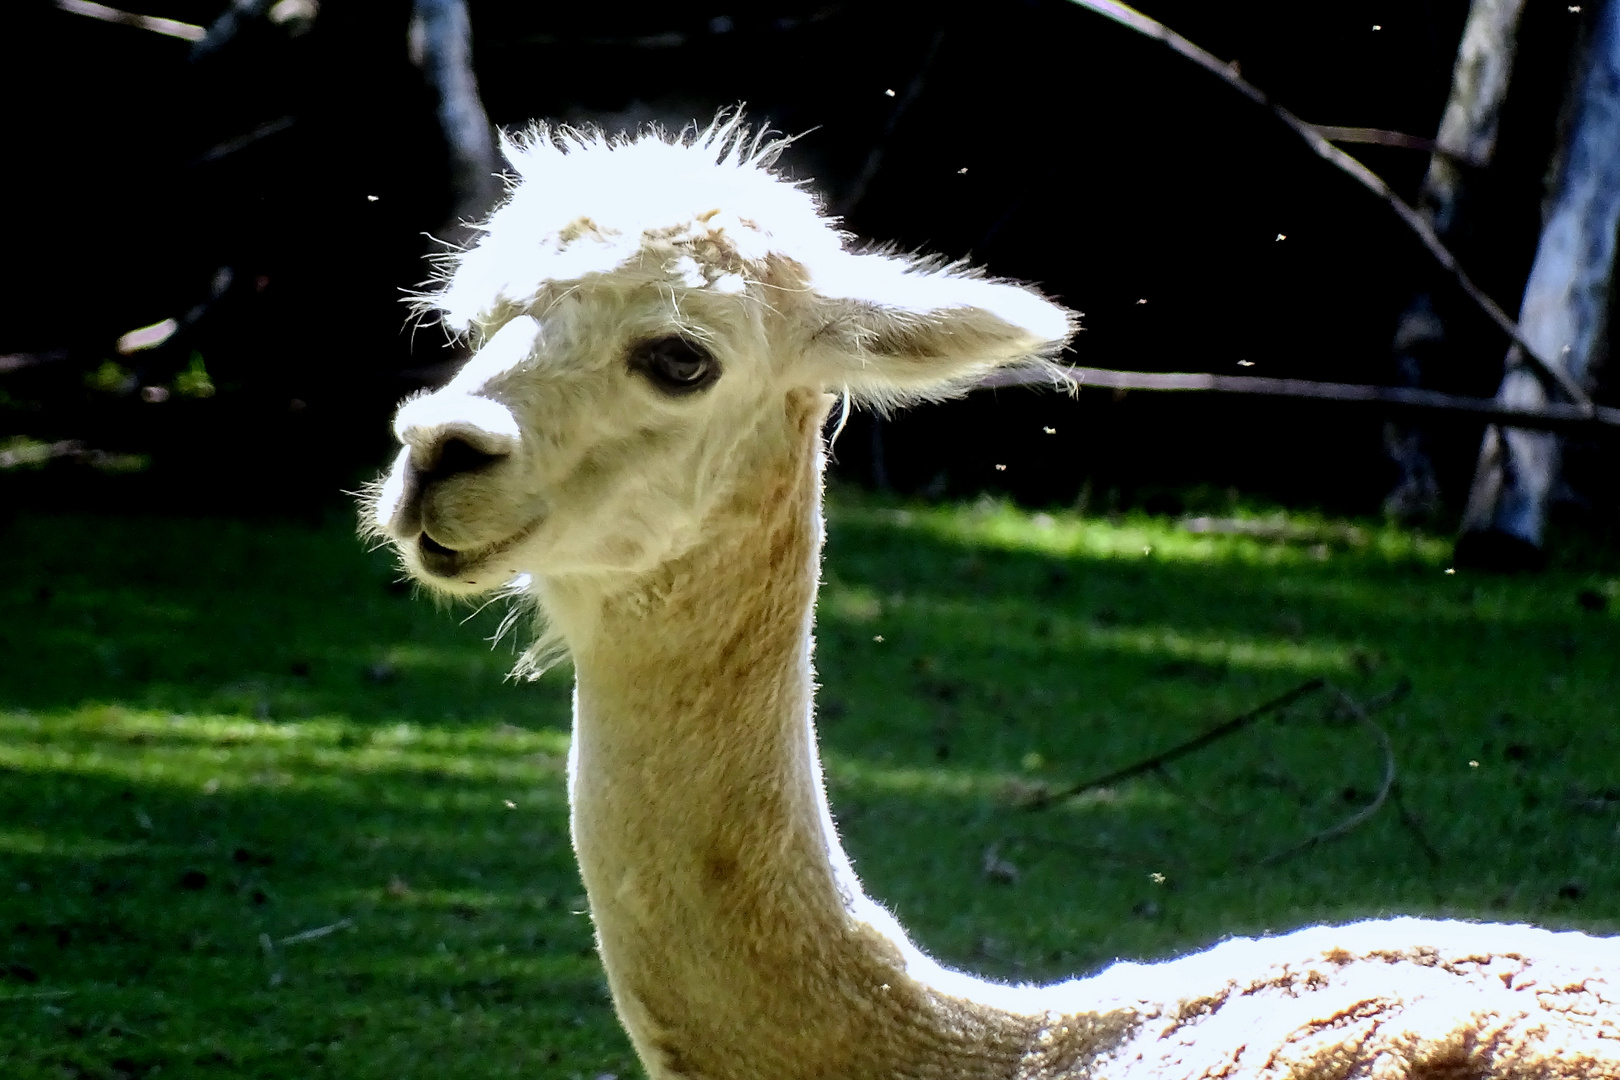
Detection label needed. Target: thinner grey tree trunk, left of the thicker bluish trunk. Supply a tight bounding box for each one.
[1383,0,1524,520]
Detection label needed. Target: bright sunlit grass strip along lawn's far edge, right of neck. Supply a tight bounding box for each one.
[828,497,1450,565]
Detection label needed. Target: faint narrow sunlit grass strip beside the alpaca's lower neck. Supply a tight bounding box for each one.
[823,751,1181,814]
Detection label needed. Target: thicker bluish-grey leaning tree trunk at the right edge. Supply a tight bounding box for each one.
[1456,0,1620,568]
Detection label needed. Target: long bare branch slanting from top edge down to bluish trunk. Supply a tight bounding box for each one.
[1069,0,1592,410]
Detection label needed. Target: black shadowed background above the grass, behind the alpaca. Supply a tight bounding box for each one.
[0,0,1615,529]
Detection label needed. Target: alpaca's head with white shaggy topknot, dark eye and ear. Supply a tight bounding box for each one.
[369,117,1072,608]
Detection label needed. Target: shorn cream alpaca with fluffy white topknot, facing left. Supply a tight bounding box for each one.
[366,115,1620,1080]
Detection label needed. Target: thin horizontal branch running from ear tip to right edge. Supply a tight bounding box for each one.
[978,368,1620,432]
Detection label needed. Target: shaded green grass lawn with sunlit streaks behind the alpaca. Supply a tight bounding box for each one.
[0,492,1620,1080]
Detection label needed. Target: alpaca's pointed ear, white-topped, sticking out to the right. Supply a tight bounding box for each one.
[807,253,1076,406]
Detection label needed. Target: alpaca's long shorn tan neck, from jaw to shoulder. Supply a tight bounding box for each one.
[552,395,1034,1080]
